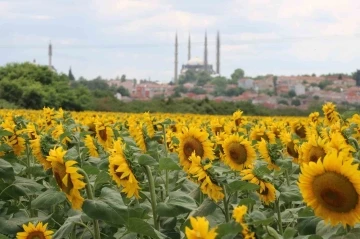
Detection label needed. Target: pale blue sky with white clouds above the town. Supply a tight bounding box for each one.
[0,0,360,82]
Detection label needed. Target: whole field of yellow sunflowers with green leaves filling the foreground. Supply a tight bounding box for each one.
[0,102,360,239]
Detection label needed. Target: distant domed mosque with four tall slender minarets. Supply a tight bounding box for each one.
[174,32,220,84]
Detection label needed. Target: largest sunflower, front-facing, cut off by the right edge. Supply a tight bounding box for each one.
[298,152,360,226]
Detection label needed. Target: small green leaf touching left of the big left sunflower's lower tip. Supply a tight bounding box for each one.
[31,189,66,209]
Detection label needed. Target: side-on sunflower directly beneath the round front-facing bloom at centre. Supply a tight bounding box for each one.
[188,152,224,201]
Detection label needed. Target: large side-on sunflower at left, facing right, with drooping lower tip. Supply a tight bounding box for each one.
[46,147,85,209]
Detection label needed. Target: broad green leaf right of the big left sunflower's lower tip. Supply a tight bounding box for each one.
[82,187,128,225]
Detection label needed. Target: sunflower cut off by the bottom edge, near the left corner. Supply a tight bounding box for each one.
[16,222,54,239]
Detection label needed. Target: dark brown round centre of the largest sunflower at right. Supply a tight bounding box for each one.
[312,172,359,213]
